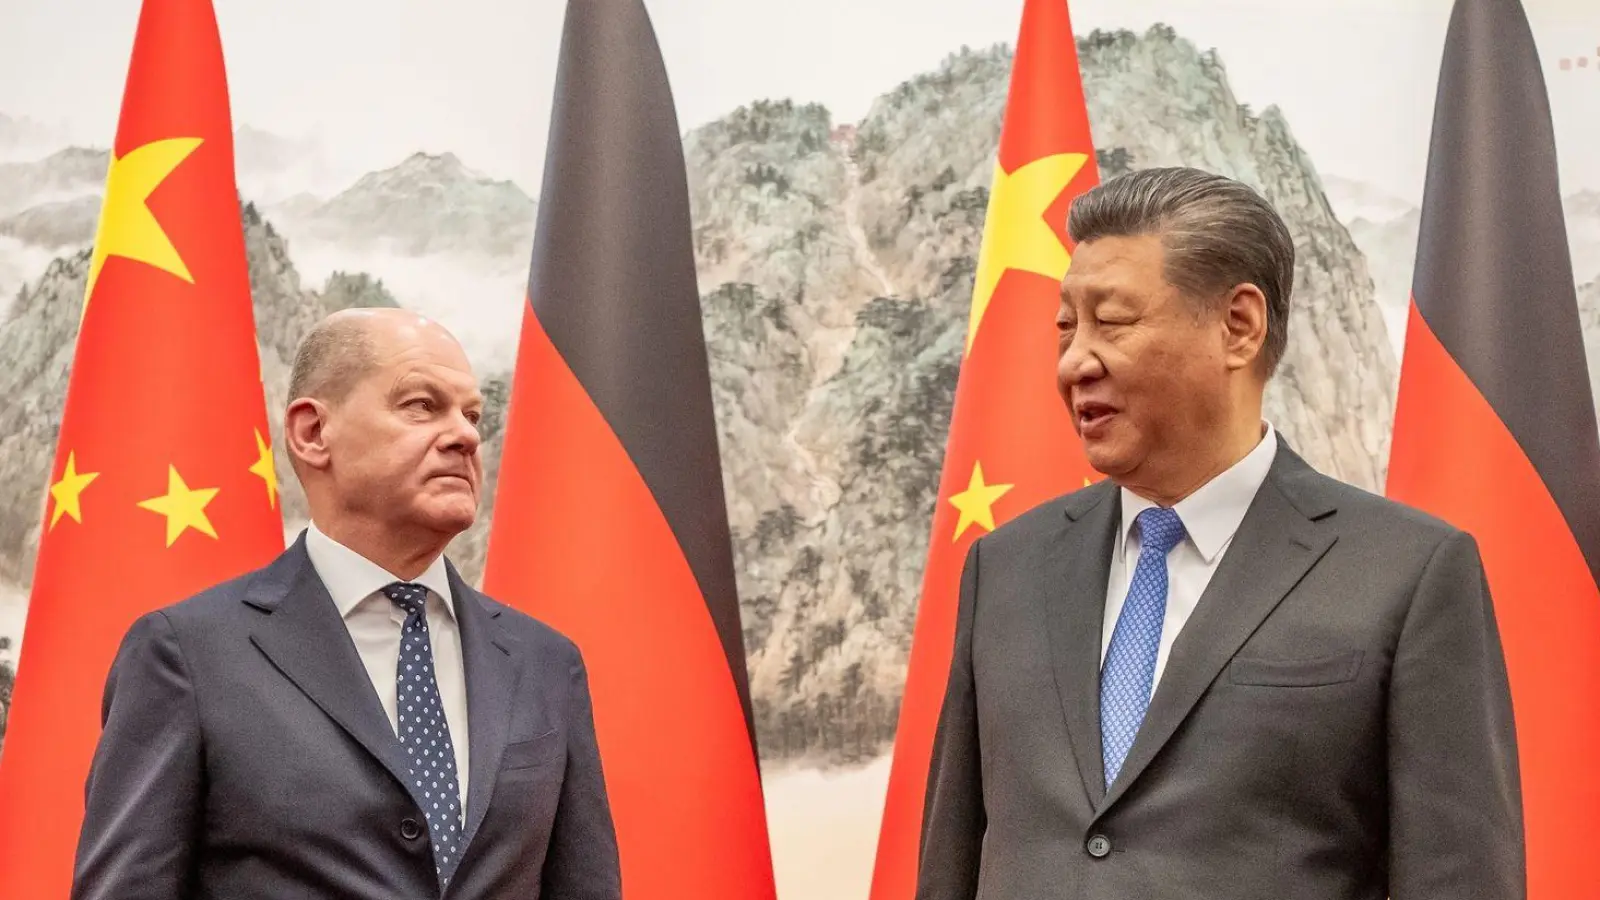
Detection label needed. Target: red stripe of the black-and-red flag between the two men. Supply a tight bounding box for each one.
[483,307,773,900]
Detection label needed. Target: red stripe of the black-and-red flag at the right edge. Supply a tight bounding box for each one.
[1389,304,1600,900]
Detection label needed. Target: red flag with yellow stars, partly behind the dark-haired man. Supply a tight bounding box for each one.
[872,0,1099,900]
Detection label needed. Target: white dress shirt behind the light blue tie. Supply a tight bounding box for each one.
[1101,424,1278,682]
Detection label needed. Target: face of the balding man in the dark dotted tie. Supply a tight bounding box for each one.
[323,322,483,535]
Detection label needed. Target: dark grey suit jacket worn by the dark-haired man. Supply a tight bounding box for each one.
[917,442,1526,900]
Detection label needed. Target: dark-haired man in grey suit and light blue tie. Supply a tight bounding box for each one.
[917,168,1526,900]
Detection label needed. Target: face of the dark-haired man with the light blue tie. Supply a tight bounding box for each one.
[1056,235,1229,484]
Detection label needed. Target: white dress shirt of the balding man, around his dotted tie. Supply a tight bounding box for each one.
[306,522,469,810]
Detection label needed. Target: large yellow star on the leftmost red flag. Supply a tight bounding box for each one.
[83,138,200,309]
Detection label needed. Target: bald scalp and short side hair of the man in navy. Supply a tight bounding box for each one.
[290,307,459,404]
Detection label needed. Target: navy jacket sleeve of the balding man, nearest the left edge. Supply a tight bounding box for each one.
[72,612,202,900]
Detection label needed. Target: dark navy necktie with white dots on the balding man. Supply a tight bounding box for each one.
[384,581,461,886]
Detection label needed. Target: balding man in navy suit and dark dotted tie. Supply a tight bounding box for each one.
[72,309,621,900]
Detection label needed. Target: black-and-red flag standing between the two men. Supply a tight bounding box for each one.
[483,0,774,900]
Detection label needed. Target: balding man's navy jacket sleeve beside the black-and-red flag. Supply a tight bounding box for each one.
[542,650,622,900]
